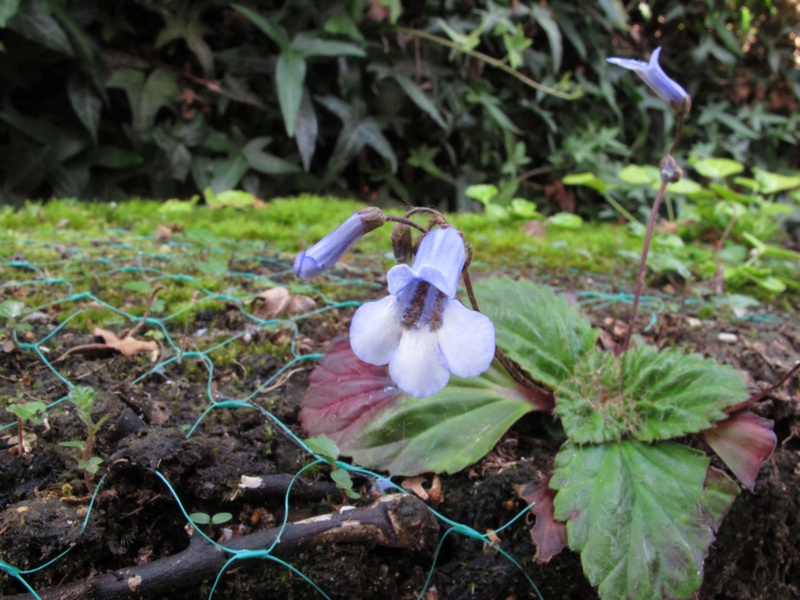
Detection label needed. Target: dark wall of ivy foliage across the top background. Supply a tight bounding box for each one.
[0,0,800,215]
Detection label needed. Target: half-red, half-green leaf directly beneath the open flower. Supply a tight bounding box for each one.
[300,338,550,475]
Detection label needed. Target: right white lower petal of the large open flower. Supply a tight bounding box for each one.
[436,300,495,377]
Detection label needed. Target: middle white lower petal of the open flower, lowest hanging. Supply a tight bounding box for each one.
[389,328,450,398]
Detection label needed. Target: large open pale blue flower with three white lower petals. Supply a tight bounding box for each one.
[350,227,495,398]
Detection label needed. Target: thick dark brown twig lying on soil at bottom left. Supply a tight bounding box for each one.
[5,494,437,600]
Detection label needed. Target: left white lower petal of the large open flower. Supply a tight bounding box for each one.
[350,296,403,365]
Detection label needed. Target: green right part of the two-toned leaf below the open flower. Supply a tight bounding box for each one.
[341,361,536,475]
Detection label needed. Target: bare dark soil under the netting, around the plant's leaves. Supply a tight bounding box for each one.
[0,270,800,600]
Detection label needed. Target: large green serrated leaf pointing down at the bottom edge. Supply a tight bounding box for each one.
[550,440,738,600]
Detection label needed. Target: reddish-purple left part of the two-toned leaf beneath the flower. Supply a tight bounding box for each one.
[299,336,406,449]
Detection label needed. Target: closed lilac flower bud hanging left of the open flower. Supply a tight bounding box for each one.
[294,207,386,281]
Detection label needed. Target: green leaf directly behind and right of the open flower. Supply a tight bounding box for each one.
[475,278,598,389]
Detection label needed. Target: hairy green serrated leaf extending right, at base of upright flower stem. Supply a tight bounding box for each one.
[556,346,749,444]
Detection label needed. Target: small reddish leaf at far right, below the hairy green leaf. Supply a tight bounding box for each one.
[703,410,777,491]
